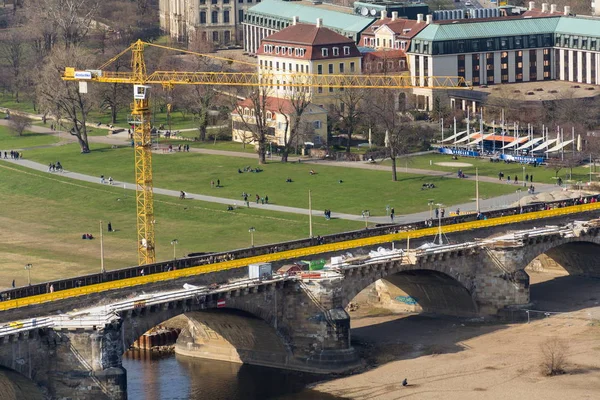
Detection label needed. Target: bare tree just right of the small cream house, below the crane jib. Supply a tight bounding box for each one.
[333,88,366,153]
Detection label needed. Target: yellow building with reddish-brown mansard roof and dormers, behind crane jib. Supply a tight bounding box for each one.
[257,19,361,107]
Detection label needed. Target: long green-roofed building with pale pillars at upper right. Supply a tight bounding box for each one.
[407,6,600,108]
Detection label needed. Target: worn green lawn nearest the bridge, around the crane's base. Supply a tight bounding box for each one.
[0,162,362,287]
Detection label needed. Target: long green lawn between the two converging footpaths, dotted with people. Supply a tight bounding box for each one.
[21,145,513,215]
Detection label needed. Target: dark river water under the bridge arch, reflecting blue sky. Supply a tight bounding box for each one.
[123,351,339,400]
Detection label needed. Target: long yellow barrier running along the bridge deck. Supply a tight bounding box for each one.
[0,202,600,311]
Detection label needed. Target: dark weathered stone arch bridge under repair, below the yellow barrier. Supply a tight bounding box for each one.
[0,222,600,399]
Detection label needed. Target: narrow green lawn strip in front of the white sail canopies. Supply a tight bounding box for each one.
[385,154,597,183]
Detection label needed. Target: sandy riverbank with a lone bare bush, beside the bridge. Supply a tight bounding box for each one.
[315,274,600,400]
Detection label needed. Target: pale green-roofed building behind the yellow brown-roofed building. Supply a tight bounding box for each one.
[243,0,375,54]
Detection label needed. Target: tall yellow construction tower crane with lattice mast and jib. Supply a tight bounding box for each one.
[62,40,470,265]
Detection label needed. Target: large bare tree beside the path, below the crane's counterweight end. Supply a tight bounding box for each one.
[37,47,96,153]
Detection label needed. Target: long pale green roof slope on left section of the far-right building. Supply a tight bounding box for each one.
[414,16,560,41]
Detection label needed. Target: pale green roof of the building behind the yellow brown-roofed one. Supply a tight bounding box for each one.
[248,0,375,34]
